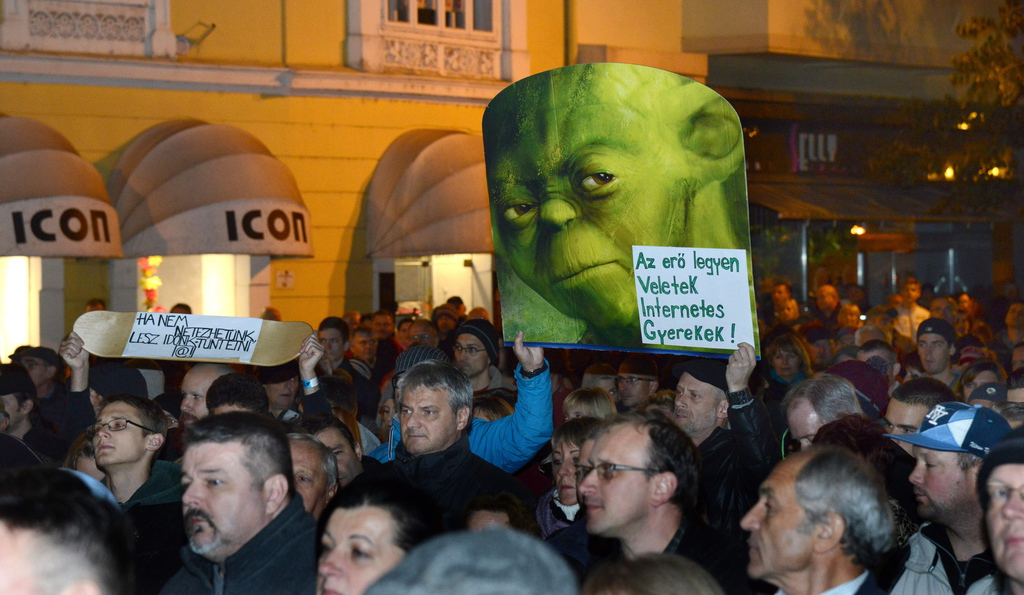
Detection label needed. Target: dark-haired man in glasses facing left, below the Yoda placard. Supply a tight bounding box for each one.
[577,412,750,594]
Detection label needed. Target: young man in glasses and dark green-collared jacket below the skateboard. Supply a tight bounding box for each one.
[86,394,185,593]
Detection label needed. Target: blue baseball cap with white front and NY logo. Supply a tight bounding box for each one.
[886,401,1011,458]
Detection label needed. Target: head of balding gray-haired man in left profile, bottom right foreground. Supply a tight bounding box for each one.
[742,448,897,595]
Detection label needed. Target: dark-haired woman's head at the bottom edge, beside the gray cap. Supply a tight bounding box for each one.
[316,479,443,595]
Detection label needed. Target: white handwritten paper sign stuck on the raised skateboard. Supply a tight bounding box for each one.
[122,312,263,363]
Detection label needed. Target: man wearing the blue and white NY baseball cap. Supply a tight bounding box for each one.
[879,401,1010,595]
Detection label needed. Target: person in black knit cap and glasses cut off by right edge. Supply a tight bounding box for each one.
[978,429,1024,595]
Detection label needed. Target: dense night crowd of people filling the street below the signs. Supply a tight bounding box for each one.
[6,278,1024,595]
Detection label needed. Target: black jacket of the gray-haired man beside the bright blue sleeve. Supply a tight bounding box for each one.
[356,435,535,528]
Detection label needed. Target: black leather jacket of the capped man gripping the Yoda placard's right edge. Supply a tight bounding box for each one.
[697,390,781,540]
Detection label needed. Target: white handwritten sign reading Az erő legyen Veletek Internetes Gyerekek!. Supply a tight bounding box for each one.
[633,246,757,352]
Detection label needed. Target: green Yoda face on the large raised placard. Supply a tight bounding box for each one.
[483,65,746,345]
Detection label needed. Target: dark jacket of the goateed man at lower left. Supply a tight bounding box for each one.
[161,495,316,595]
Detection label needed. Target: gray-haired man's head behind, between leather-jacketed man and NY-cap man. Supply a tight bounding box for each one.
[782,376,863,449]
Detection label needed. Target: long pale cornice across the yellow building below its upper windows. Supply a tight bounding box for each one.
[0,52,508,105]
